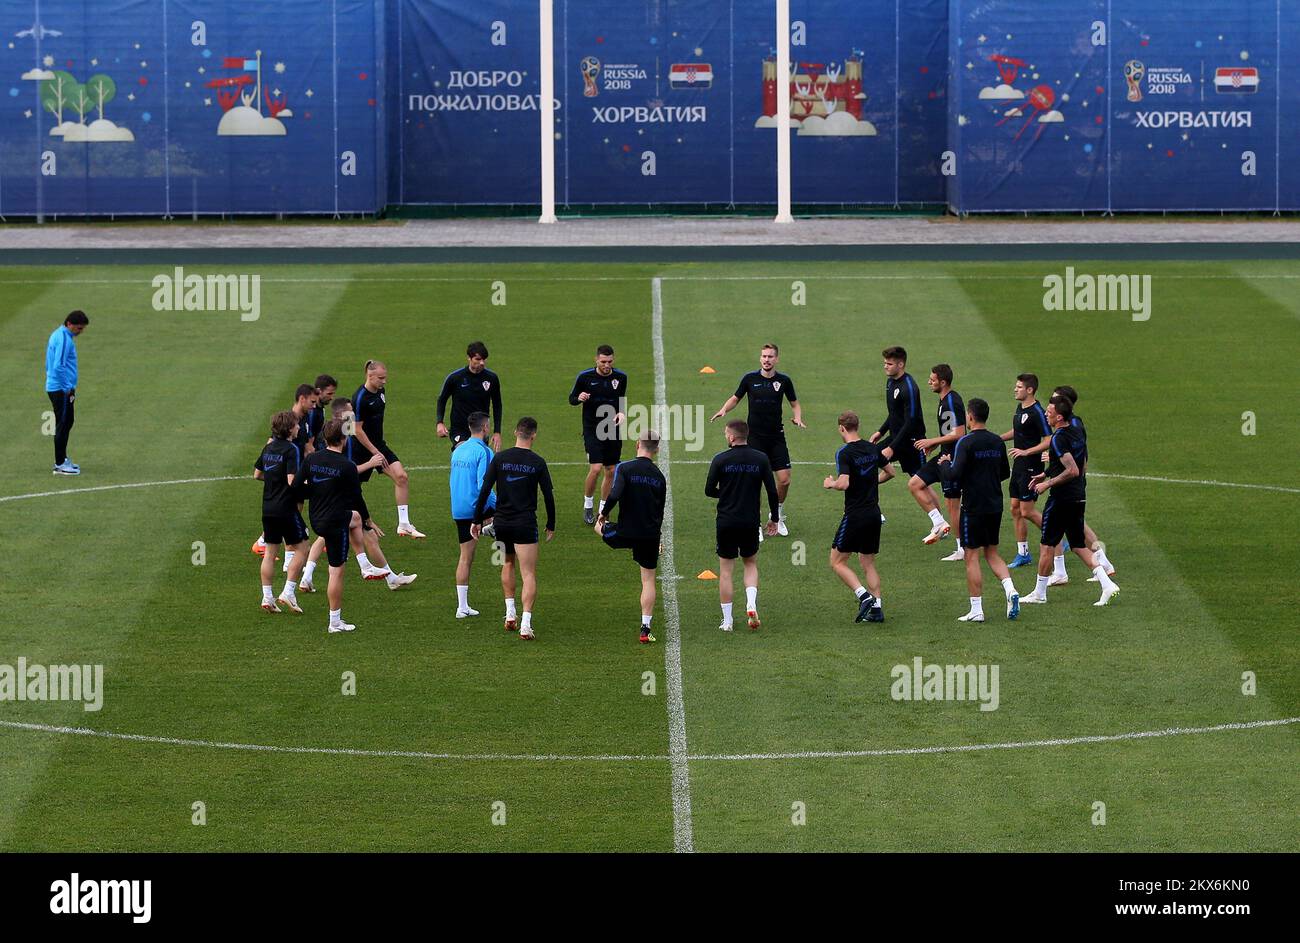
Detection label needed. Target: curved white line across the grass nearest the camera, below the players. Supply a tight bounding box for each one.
[0,717,1300,764]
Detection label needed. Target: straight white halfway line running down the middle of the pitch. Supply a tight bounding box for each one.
[650,278,696,852]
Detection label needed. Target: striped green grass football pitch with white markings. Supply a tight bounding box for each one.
[0,251,1300,852]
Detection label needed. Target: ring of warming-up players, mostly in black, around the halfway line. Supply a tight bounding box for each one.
[254,341,1119,643]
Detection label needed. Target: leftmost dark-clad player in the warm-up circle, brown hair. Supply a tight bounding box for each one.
[252,408,315,613]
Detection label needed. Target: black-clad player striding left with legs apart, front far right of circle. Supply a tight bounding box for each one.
[1021,393,1119,606]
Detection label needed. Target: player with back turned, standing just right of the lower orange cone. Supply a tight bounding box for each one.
[705,421,781,632]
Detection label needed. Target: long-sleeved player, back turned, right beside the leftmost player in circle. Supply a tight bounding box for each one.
[297,419,374,633]
